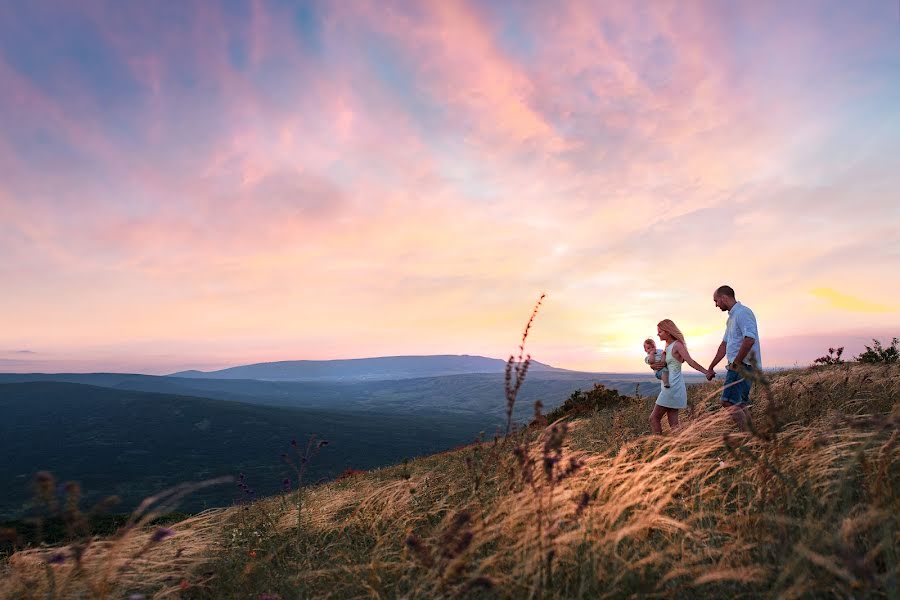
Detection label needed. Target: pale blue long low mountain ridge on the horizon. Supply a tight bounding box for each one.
[170,354,569,381]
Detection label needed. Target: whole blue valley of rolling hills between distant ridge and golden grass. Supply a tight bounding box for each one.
[0,370,684,517]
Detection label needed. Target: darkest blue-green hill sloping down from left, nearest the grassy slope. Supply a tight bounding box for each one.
[0,382,499,518]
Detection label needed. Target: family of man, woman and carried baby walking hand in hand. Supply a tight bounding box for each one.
[644,285,762,433]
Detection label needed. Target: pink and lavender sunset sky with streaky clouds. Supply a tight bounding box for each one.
[0,0,900,373]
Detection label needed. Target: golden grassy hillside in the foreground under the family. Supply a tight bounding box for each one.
[0,365,900,599]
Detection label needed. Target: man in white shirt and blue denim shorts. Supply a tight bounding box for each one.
[706,285,762,431]
